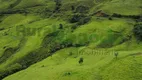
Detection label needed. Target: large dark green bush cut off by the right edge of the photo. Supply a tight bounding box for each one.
[133,24,142,41]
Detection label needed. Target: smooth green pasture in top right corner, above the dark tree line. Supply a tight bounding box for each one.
[93,0,142,15]
